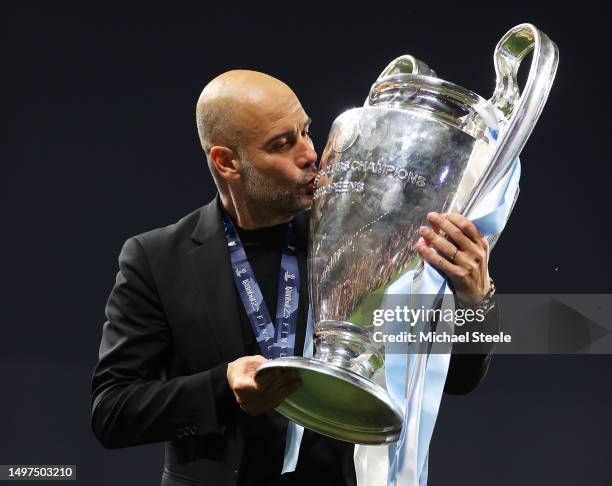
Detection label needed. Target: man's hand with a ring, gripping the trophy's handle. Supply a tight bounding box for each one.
[414,213,491,305]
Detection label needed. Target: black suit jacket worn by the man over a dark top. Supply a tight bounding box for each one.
[91,197,488,486]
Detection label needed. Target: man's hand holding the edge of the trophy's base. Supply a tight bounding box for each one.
[227,355,301,415]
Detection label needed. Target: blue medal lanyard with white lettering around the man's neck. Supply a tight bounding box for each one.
[223,211,300,359]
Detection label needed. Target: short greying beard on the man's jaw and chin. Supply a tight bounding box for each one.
[242,159,313,216]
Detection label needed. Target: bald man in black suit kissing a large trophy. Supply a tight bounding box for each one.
[91,71,498,486]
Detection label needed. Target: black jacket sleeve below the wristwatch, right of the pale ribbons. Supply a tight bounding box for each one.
[444,300,499,395]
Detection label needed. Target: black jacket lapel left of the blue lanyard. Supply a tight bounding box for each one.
[189,196,246,361]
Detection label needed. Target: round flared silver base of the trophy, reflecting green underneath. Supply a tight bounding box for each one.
[256,356,403,445]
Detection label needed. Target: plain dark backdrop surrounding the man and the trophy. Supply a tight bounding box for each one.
[0,2,612,486]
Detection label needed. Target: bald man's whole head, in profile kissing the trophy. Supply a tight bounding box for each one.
[196,71,317,224]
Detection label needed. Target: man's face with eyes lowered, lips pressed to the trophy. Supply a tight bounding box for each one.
[240,95,317,215]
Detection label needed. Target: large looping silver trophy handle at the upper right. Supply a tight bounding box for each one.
[461,24,559,215]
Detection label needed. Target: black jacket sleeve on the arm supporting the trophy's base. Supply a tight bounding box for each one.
[91,238,237,449]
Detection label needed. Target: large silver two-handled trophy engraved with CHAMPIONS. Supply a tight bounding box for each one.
[258,24,558,444]
